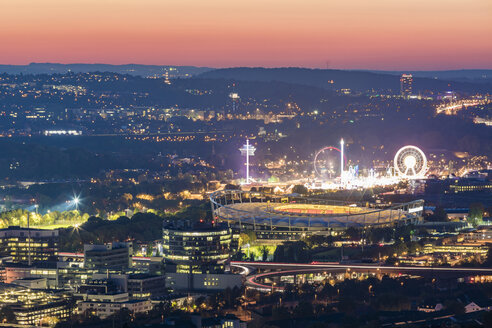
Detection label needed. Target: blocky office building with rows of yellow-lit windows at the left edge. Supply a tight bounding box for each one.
[0,226,58,263]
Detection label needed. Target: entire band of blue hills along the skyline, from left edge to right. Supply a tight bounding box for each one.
[0,63,492,93]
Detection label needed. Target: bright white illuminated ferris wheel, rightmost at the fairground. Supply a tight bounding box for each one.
[394,146,427,179]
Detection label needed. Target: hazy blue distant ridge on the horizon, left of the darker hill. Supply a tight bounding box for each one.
[0,63,212,77]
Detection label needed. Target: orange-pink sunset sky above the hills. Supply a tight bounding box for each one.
[0,0,492,70]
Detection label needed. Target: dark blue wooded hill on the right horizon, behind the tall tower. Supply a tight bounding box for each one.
[199,67,492,92]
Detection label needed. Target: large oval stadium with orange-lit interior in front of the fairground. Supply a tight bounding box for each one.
[210,190,424,239]
